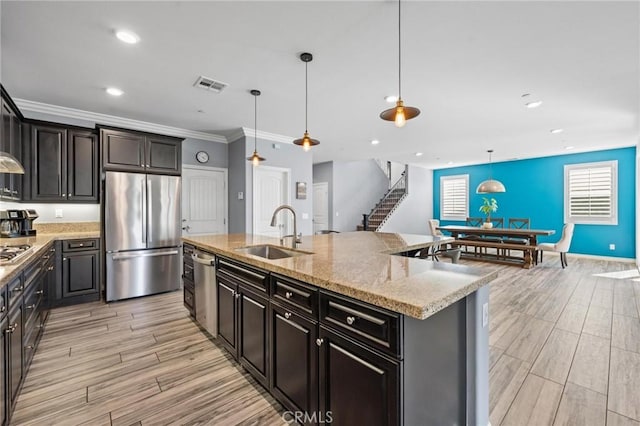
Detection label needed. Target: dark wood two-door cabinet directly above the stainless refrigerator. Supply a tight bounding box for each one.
[100,128,182,175]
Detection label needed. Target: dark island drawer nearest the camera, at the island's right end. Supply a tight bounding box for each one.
[320,292,400,356]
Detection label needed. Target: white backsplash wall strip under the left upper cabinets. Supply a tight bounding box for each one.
[0,201,100,224]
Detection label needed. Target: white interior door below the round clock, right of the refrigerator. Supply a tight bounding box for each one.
[182,166,228,236]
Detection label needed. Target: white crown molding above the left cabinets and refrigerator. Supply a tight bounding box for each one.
[14,98,227,143]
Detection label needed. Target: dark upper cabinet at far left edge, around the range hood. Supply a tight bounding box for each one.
[0,88,23,200]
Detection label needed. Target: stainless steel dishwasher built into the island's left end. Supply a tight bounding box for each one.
[191,250,218,337]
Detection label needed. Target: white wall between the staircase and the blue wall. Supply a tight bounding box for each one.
[380,166,433,234]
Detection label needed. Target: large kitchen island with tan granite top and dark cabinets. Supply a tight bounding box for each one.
[183,232,497,425]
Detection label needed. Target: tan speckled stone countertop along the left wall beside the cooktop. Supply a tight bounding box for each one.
[0,231,100,288]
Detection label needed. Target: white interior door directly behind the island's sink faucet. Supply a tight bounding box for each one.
[253,166,293,238]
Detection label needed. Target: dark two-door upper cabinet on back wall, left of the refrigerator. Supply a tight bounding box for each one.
[30,123,99,203]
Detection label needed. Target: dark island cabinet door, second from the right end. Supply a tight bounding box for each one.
[270,303,318,424]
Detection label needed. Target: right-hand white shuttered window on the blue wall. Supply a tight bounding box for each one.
[564,161,618,225]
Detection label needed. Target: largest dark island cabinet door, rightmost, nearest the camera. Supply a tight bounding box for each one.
[320,326,401,426]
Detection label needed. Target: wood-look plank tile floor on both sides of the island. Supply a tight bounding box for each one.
[12,256,640,426]
